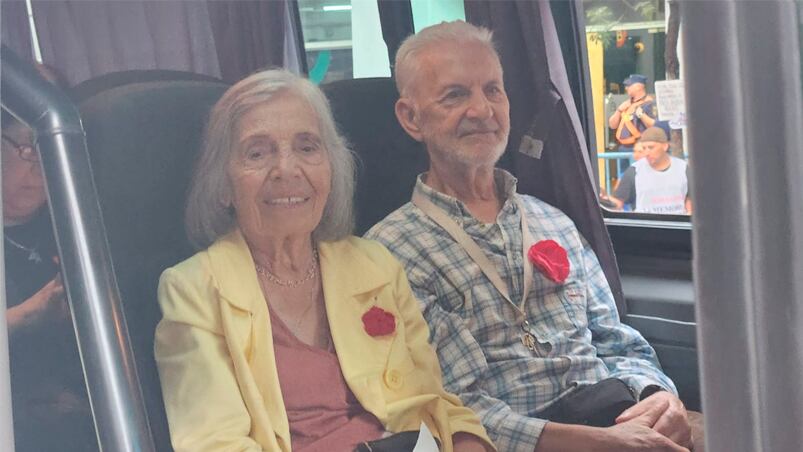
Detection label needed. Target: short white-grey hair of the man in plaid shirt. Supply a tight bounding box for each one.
[394,20,499,95]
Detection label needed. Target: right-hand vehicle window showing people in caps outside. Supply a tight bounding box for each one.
[583,0,693,219]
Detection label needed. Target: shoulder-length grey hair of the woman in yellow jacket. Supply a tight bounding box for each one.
[185,69,355,249]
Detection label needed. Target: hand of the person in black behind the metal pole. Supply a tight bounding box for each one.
[6,275,69,334]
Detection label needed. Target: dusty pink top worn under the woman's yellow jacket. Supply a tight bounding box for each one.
[270,310,384,452]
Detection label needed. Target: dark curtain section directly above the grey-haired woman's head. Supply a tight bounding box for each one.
[206,0,288,83]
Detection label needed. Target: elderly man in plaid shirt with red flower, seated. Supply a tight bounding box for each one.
[367,21,690,451]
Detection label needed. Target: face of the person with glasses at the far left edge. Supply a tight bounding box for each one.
[2,123,47,225]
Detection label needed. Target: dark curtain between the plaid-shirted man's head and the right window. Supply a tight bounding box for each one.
[465,0,626,314]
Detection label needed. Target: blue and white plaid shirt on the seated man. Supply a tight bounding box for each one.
[366,170,677,452]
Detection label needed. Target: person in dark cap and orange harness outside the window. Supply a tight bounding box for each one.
[608,74,656,152]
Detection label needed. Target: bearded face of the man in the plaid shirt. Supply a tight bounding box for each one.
[396,43,510,166]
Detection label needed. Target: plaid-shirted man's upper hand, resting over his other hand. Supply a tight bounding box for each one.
[616,391,691,447]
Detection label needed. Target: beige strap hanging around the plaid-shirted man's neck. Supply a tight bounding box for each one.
[412,191,533,321]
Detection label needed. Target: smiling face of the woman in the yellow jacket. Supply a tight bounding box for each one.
[228,93,332,245]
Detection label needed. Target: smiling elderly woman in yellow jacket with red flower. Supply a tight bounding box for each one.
[151,70,492,452]
